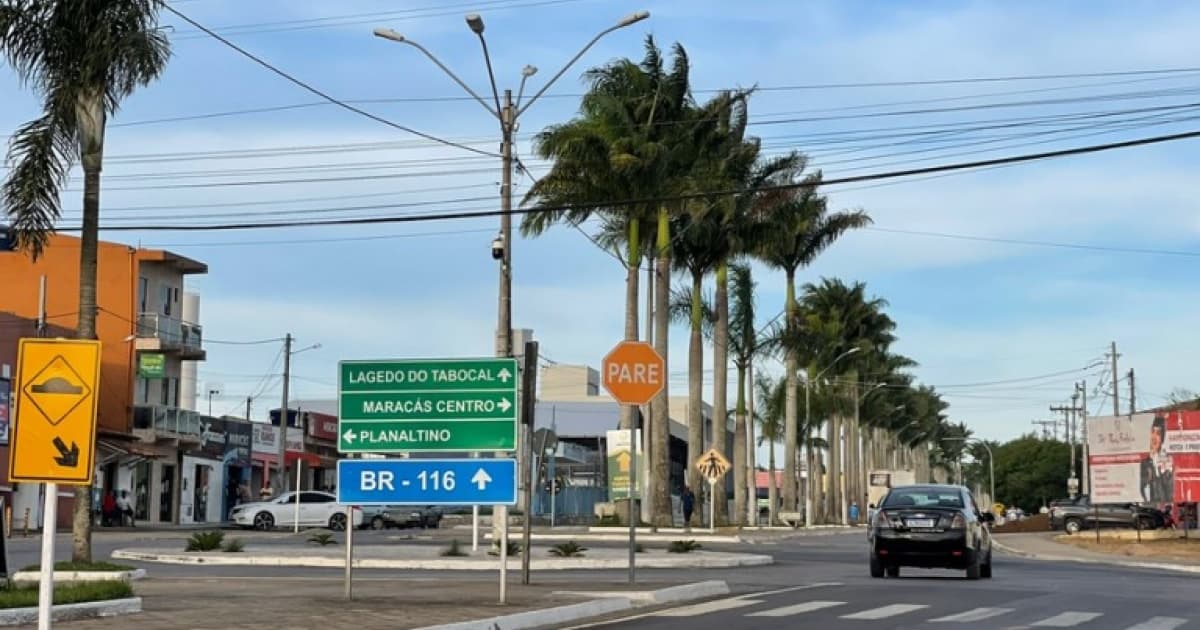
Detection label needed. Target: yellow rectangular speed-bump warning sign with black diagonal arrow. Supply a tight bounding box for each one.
[8,338,100,485]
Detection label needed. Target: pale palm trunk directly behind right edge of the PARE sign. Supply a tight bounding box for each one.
[650,208,673,527]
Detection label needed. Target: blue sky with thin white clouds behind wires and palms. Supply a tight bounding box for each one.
[0,0,1200,438]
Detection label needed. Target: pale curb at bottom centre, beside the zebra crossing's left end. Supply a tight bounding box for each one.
[418,581,730,630]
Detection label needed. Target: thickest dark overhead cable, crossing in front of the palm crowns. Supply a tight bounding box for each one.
[51,131,1200,232]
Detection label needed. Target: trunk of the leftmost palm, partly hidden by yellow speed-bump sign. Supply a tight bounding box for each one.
[73,164,101,563]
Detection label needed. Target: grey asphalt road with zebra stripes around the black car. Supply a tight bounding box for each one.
[568,535,1200,630]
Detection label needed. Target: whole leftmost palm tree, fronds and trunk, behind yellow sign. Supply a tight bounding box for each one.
[0,0,170,562]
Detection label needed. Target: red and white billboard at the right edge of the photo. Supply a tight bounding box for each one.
[1087,412,1200,504]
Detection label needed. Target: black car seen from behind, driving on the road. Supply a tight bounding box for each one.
[868,485,996,580]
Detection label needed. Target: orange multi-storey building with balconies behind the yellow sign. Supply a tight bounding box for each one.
[0,227,208,522]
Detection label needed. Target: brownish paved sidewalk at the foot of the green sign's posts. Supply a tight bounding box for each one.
[56,576,671,630]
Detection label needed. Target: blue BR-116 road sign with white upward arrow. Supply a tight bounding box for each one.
[337,458,517,505]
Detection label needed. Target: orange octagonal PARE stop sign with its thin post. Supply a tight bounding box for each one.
[600,341,666,584]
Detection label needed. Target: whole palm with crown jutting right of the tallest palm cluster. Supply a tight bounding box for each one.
[756,166,871,510]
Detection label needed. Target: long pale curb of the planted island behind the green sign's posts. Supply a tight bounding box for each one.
[113,550,775,571]
